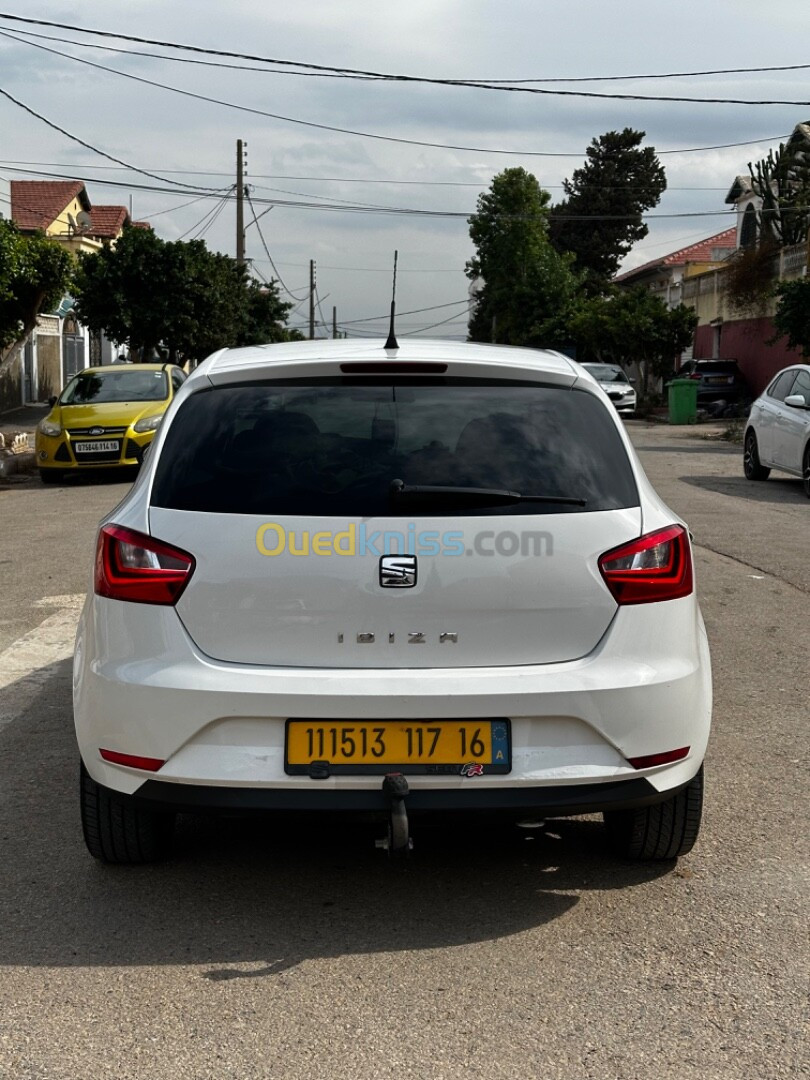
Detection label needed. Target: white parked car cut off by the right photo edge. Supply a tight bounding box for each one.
[743,364,810,498]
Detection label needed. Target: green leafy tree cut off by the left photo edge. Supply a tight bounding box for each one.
[0,220,72,355]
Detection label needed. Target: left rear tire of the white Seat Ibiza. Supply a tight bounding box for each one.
[80,762,175,866]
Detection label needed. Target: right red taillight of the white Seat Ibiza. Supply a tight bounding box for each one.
[599,525,693,604]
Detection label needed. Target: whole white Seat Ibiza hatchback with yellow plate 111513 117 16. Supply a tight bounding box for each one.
[73,340,712,863]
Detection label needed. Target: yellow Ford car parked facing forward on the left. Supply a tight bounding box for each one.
[36,364,186,484]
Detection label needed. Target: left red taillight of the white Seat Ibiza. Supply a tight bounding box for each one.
[95,525,194,604]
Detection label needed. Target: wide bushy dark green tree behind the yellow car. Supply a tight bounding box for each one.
[75,228,291,363]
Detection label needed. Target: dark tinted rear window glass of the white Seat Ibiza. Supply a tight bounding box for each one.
[152,377,638,517]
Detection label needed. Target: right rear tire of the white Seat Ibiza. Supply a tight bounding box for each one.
[604,766,703,862]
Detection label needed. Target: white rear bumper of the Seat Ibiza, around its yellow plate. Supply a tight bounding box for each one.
[73,596,712,813]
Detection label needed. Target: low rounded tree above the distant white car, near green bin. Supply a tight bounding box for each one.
[569,286,698,397]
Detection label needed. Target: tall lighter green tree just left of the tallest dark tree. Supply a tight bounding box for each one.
[465,168,579,347]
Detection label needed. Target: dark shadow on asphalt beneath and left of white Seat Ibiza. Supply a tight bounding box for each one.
[0,672,673,982]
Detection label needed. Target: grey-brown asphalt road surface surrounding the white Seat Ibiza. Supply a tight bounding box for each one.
[0,423,810,1080]
